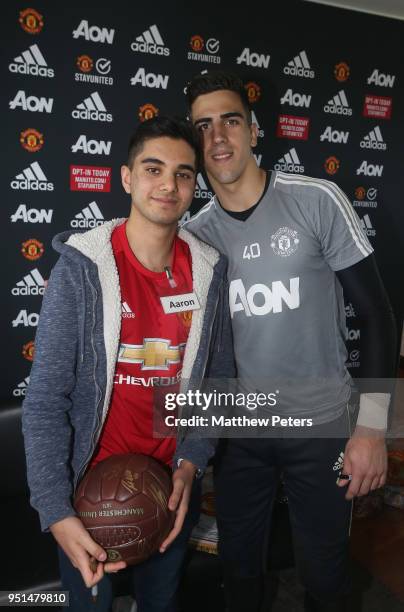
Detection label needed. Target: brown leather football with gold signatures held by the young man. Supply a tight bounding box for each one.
[74,454,175,565]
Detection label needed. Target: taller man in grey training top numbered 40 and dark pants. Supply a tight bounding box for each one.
[186,72,396,612]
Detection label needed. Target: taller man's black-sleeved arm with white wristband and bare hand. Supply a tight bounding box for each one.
[336,254,397,499]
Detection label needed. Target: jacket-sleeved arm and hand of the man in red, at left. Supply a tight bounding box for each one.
[23,260,126,587]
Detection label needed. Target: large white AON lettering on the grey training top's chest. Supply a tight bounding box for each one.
[229,277,300,318]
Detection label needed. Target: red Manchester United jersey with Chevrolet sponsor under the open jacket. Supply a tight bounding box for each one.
[92,223,192,464]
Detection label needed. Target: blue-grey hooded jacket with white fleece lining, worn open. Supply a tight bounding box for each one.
[23,219,235,529]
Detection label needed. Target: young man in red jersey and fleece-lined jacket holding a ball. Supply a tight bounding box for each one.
[23,117,234,612]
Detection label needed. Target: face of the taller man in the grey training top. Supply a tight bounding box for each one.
[191,89,257,184]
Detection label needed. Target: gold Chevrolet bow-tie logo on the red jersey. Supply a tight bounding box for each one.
[118,338,185,370]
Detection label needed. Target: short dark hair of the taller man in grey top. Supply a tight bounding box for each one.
[186,70,251,123]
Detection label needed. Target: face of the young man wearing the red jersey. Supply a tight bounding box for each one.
[121,136,196,225]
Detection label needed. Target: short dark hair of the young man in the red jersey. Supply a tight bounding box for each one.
[127,115,201,171]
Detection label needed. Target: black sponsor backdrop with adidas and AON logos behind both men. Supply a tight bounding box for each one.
[1,2,404,401]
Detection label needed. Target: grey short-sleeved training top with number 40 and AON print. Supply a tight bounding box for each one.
[185,172,373,424]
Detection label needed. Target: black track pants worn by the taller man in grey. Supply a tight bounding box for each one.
[215,414,352,612]
